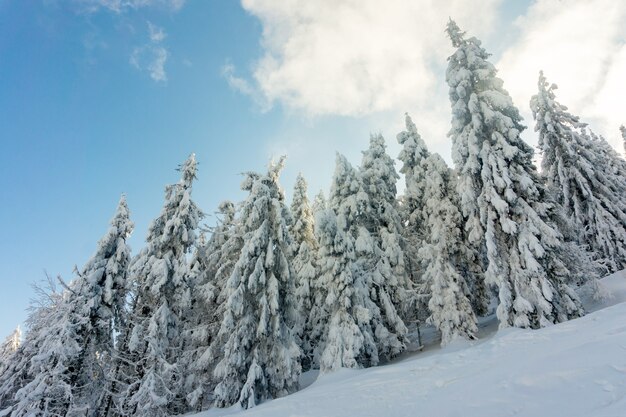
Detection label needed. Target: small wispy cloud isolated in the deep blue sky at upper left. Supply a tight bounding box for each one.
[130,22,169,82]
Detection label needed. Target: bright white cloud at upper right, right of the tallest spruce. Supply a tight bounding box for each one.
[496,0,626,149]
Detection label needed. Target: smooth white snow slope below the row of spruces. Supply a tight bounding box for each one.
[196,271,626,417]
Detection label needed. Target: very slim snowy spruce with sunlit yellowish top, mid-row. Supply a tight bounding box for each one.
[289,174,318,371]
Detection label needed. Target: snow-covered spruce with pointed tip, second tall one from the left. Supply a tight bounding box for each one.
[120,154,202,416]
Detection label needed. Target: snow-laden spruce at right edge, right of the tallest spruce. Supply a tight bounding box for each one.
[530,73,626,272]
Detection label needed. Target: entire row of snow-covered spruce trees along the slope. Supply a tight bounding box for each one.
[0,20,626,417]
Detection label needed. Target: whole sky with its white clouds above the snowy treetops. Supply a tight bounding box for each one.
[0,0,626,337]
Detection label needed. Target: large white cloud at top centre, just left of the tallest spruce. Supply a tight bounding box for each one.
[242,0,499,116]
